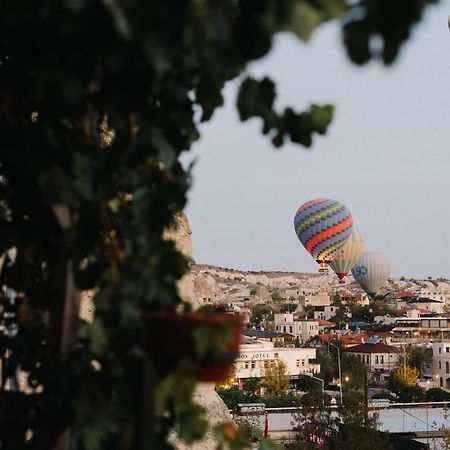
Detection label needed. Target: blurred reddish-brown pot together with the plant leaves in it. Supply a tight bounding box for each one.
[144,305,242,382]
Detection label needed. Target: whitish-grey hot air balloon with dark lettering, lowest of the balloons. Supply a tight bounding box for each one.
[352,252,391,297]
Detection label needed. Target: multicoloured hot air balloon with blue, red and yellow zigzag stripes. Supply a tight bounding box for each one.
[294,198,353,267]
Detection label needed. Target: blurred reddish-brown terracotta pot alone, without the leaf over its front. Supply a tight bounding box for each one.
[145,313,242,382]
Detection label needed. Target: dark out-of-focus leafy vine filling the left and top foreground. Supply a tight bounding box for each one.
[0,0,436,450]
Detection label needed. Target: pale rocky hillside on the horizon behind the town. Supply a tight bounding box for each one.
[192,265,450,303]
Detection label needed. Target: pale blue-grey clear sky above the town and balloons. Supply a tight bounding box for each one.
[185,4,450,277]
